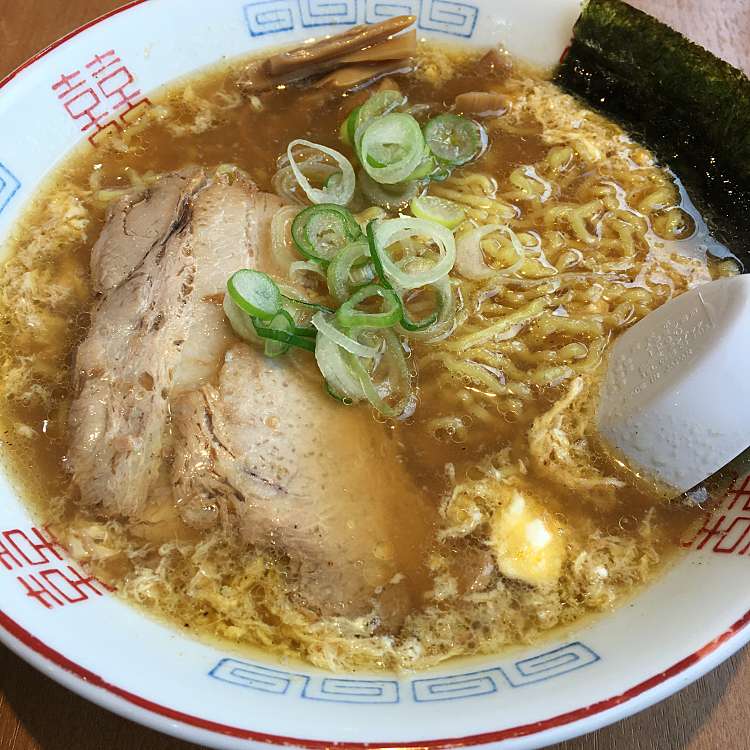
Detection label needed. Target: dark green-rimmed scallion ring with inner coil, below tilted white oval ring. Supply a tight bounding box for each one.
[292,203,362,263]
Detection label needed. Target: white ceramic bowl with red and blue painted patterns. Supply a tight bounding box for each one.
[0,0,750,748]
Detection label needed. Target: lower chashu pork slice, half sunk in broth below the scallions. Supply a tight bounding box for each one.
[173,344,434,615]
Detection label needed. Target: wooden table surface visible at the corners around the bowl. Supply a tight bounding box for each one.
[0,0,750,750]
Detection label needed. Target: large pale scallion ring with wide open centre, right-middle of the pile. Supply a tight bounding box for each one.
[367,216,456,289]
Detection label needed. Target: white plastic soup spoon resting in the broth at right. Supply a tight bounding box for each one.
[597,275,750,492]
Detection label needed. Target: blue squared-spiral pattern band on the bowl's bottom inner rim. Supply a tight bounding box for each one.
[208,641,600,703]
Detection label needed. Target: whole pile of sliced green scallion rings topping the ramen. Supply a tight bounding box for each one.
[224,91,494,412]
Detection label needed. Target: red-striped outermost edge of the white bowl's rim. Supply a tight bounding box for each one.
[0,0,750,750]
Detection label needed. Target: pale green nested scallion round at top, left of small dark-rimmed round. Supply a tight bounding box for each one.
[359,112,424,185]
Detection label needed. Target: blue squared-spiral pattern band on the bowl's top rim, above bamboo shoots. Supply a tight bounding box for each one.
[243,0,479,39]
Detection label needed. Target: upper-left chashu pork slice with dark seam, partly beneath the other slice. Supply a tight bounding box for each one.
[67,169,282,519]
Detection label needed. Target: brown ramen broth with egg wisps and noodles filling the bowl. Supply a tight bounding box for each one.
[0,46,736,668]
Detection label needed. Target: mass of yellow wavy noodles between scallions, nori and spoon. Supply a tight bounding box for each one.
[421,80,710,440]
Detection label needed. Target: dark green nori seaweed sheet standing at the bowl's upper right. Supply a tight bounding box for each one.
[555,0,750,262]
